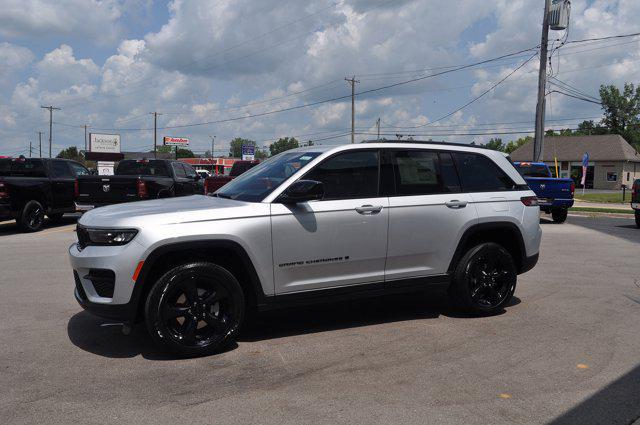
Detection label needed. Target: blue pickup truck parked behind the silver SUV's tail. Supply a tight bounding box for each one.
[513,162,576,223]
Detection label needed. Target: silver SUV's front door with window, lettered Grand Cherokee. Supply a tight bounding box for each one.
[271,149,389,294]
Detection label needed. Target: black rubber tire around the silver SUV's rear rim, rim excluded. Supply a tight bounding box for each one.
[452,242,518,315]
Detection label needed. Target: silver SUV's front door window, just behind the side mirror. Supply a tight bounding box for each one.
[303,150,378,200]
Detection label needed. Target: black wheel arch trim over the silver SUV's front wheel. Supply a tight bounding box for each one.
[131,240,266,320]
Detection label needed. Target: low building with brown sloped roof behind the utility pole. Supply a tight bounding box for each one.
[511,134,640,189]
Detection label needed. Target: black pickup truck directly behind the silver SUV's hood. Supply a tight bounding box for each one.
[76,159,204,211]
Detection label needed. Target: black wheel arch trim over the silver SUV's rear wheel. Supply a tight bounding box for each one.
[447,221,527,273]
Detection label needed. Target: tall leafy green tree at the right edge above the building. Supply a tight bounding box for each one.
[600,83,640,145]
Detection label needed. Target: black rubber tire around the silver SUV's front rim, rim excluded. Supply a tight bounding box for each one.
[144,262,245,357]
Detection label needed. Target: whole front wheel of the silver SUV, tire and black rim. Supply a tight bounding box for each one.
[144,262,245,357]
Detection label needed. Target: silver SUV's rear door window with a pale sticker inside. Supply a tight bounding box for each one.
[394,150,443,196]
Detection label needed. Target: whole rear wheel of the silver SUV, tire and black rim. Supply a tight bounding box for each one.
[449,242,518,316]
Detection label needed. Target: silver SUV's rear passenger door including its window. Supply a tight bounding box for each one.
[383,148,477,285]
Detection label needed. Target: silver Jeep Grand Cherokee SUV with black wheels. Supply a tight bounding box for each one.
[69,142,541,356]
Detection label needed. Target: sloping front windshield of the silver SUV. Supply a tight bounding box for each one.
[214,152,322,202]
